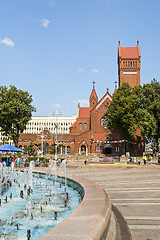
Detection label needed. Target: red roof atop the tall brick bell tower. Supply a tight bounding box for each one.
[118,46,141,59]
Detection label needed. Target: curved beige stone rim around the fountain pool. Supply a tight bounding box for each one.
[36,172,116,240]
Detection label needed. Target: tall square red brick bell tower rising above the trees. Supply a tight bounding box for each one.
[118,41,141,88]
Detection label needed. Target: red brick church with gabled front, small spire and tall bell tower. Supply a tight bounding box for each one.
[19,41,142,155]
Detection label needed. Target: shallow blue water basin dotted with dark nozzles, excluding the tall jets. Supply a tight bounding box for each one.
[0,173,83,240]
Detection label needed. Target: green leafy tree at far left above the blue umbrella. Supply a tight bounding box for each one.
[0,85,35,146]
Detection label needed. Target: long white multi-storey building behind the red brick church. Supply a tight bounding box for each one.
[23,115,77,134]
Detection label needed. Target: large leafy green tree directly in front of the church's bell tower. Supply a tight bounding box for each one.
[105,83,156,142]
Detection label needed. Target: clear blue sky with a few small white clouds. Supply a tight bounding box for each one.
[0,0,160,116]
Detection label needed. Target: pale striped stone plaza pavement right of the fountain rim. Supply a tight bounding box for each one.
[67,163,160,240]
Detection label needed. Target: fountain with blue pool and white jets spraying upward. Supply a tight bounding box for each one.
[0,160,84,240]
